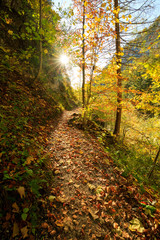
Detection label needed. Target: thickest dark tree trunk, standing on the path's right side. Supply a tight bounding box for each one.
[113,0,122,136]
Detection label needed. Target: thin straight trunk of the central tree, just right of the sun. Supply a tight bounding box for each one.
[82,1,86,109]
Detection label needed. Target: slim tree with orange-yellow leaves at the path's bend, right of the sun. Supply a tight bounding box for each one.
[71,0,113,108]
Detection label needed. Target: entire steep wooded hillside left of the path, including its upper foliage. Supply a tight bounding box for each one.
[0,0,76,239]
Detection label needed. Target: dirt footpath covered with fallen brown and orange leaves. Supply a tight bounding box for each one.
[41,111,157,240]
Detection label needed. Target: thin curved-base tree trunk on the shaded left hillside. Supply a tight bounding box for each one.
[35,0,42,80]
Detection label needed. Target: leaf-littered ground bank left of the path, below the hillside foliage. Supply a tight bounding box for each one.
[0,66,77,239]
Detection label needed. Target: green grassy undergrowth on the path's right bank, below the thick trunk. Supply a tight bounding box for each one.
[106,141,160,193]
